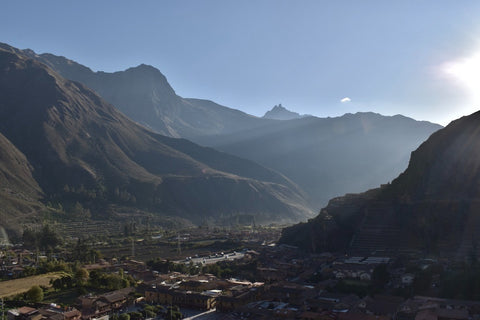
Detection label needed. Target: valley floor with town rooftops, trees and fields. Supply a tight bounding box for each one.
[0,227,480,320]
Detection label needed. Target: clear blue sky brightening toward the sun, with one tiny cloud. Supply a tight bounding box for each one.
[0,0,480,124]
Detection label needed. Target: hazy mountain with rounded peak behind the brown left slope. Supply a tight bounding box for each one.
[15,44,269,140]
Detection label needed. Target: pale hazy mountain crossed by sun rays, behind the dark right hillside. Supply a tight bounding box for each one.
[197,112,441,208]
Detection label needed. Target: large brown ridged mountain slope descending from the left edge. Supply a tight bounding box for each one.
[0,45,311,231]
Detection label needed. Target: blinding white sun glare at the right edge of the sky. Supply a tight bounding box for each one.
[444,52,480,103]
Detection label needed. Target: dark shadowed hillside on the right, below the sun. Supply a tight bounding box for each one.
[281,112,480,260]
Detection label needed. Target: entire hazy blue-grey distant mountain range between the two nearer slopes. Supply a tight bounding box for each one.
[16,46,441,210]
